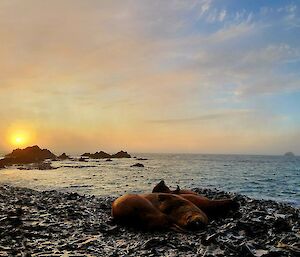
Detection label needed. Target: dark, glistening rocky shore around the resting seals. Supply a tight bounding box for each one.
[0,186,300,257]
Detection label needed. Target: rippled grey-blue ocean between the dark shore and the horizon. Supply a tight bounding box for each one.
[0,154,300,207]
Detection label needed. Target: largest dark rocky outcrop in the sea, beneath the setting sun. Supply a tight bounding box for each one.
[0,145,56,166]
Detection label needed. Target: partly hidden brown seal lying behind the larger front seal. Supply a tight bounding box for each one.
[152,180,239,217]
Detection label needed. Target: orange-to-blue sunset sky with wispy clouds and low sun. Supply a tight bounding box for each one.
[0,0,300,154]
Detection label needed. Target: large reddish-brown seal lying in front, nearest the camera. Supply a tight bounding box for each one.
[112,193,208,231]
